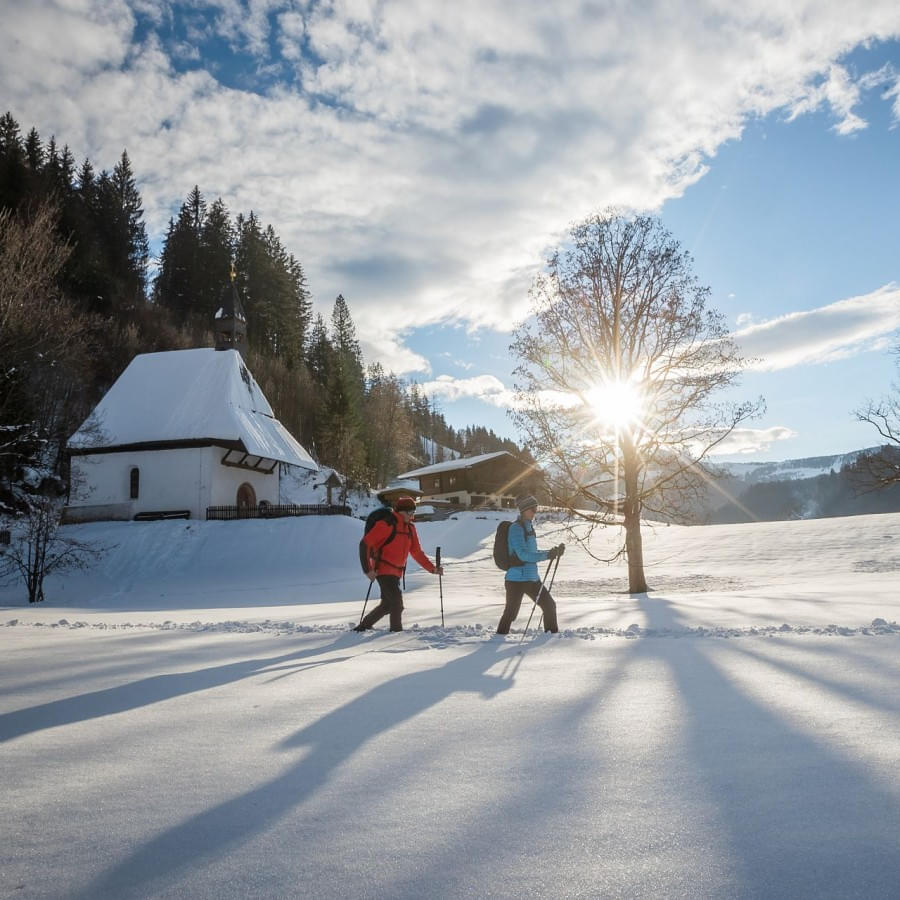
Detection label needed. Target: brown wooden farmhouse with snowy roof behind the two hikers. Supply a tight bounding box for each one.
[397,450,537,509]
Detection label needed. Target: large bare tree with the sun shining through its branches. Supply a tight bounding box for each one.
[512,210,763,593]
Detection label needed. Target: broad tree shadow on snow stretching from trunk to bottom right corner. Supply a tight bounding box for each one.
[635,595,900,898]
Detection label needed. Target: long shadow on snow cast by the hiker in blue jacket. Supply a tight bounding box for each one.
[80,642,521,900]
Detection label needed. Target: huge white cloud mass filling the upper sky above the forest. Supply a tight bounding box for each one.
[0,0,900,372]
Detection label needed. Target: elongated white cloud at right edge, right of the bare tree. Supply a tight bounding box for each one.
[732,284,900,372]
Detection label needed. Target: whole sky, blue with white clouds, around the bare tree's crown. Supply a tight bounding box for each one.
[0,0,900,459]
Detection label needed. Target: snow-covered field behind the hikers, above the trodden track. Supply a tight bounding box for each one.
[0,512,900,629]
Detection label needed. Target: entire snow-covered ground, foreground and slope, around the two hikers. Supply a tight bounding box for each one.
[0,514,900,900]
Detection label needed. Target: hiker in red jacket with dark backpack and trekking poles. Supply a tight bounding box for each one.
[354,497,444,631]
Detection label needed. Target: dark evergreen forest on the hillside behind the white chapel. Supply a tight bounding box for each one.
[0,113,520,503]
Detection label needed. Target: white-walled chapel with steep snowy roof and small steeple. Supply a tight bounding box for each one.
[64,287,318,522]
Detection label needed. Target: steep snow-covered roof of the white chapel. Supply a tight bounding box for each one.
[68,349,318,469]
